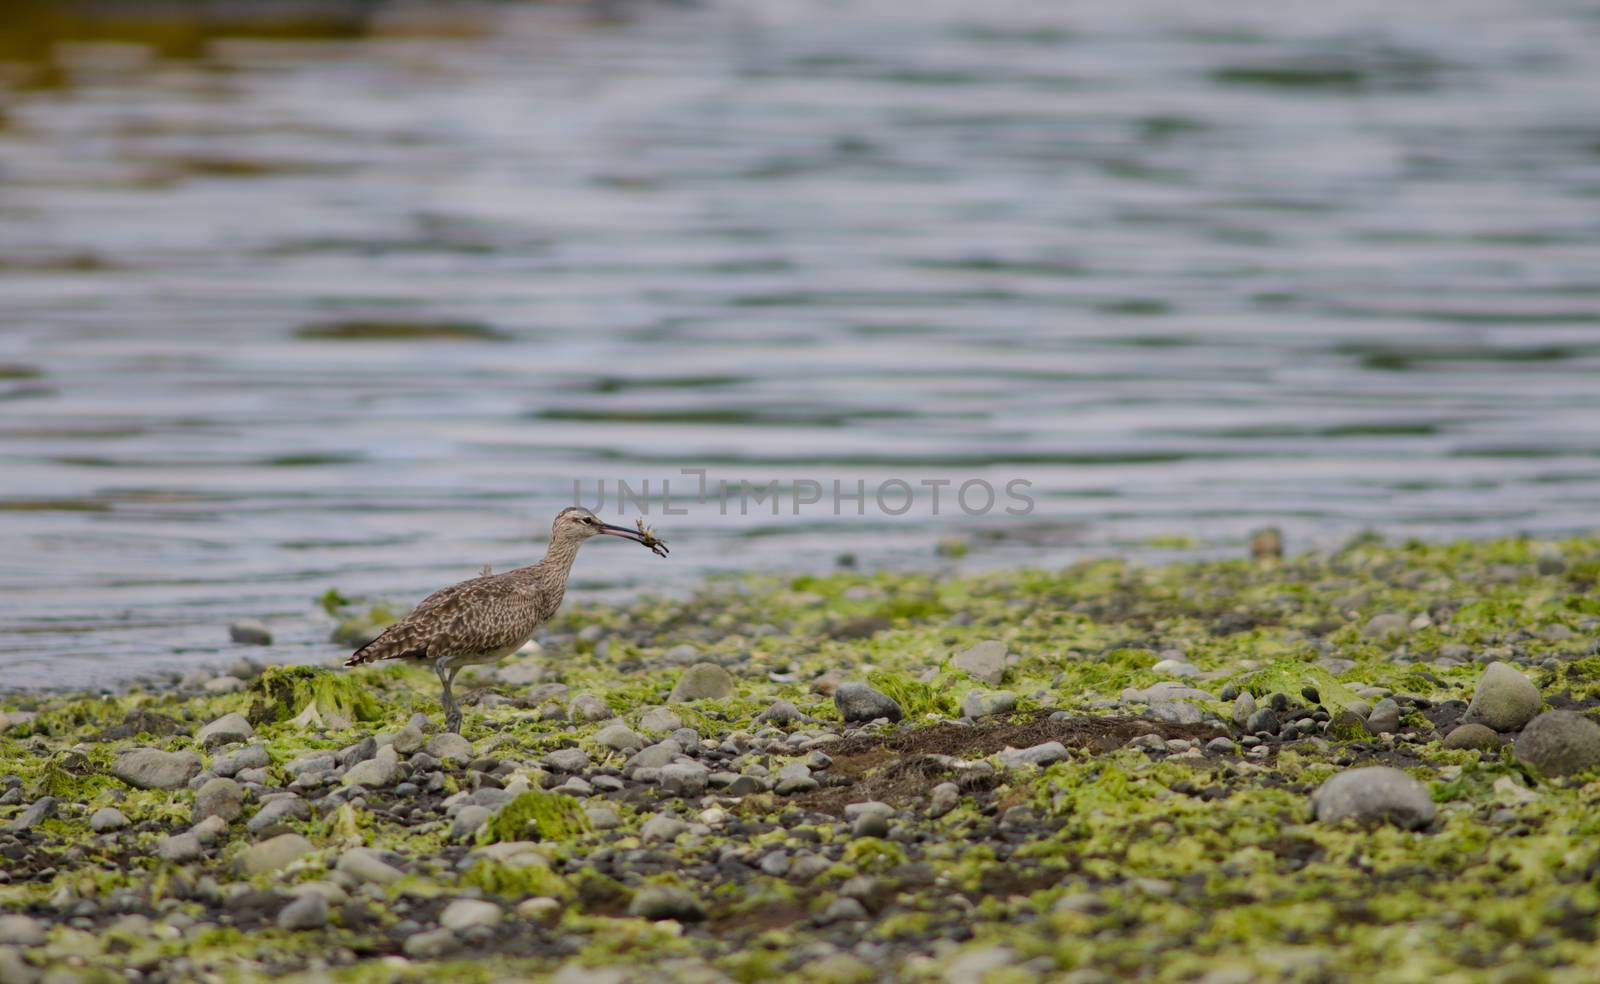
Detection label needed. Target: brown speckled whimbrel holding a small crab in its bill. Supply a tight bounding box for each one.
[344,506,667,734]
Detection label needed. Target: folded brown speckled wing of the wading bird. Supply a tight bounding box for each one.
[344,574,538,666]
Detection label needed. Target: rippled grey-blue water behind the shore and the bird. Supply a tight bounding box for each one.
[0,0,1600,688]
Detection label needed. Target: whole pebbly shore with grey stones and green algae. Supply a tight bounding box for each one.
[0,539,1600,984]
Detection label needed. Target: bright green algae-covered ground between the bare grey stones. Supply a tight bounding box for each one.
[0,539,1600,984]
